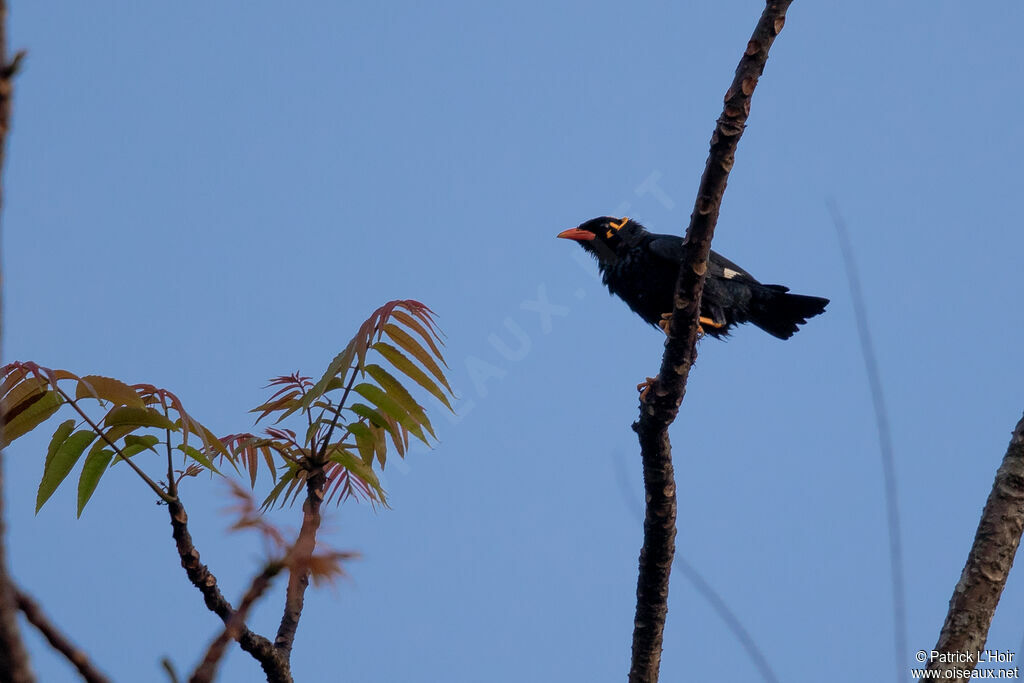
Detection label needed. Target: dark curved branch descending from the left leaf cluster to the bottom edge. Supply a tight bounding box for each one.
[167,499,292,683]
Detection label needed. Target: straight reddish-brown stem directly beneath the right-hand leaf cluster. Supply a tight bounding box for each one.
[273,466,327,661]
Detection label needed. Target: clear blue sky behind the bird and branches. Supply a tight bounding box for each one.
[3,0,1024,682]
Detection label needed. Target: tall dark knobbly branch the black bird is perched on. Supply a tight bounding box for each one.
[630,0,792,682]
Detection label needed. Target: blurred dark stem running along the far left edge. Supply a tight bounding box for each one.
[0,0,34,683]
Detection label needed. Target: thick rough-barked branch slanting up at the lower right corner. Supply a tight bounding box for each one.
[928,417,1024,672]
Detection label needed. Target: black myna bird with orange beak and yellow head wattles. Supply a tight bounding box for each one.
[558,216,828,339]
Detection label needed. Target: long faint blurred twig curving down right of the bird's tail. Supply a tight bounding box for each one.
[828,200,907,681]
